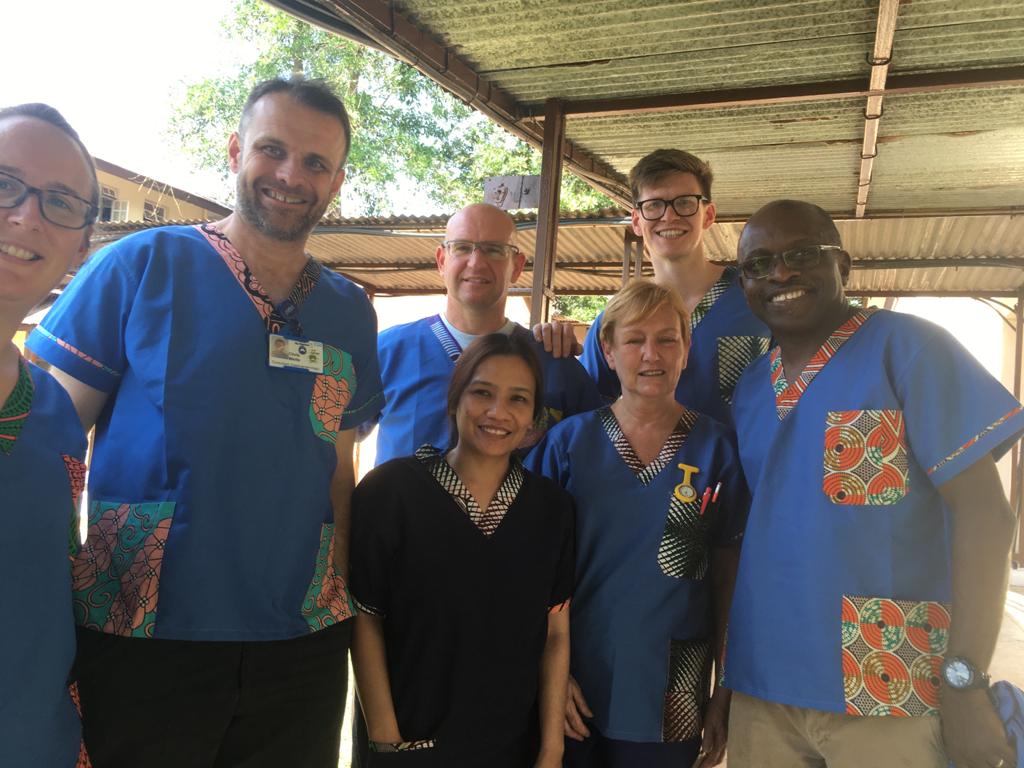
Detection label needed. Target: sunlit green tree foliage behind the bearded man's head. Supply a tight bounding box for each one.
[170,0,613,214]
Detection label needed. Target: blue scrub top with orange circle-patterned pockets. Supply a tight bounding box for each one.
[725,310,1024,716]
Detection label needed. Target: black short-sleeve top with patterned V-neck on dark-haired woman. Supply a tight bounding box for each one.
[350,446,574,768]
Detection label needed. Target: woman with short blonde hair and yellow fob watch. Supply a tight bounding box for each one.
[526,280,749,768]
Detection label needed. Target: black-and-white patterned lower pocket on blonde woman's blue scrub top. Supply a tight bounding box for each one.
[662,640,711,741]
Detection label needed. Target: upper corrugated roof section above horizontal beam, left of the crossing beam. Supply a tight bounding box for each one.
[394,0,874,103]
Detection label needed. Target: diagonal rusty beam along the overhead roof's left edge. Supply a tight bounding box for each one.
[267,0,632,206]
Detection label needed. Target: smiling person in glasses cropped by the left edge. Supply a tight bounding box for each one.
[0,103,99,768]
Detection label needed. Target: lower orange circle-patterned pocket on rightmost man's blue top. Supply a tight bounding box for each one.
[842,596,949,717]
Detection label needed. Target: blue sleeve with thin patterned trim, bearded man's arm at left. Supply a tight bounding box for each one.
[27,243,139,392]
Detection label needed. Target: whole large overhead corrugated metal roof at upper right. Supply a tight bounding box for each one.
[299,0,1024,222]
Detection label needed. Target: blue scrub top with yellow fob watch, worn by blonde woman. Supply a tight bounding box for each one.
[525,408,749,741]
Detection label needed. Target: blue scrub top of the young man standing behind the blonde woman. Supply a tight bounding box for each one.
[580,267,770,426]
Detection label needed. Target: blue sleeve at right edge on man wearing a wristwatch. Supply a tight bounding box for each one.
[896,328,1024,487]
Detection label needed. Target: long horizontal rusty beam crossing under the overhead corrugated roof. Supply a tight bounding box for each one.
[523,67,1024,121]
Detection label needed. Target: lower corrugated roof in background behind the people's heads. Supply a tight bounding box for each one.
[88,217,1024,294]
